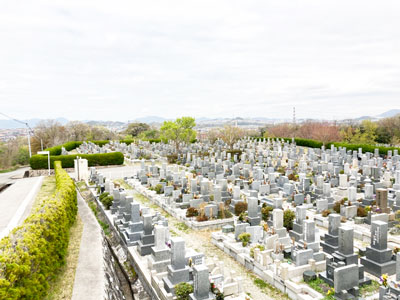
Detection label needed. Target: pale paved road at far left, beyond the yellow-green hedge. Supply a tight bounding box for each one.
[0,177,43,239]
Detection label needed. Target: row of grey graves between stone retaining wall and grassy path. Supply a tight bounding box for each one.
[90,168,250,300]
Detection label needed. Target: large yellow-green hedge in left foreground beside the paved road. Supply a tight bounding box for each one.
[0,162,77,300]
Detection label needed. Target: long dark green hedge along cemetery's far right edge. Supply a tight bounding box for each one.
[255,137,400,155]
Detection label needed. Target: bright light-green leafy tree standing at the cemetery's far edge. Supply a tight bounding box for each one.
[160,117,196,153]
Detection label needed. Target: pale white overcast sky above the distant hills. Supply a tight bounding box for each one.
[0,0,400,121]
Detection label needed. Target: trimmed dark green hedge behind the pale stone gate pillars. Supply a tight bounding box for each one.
[30,152,124,170]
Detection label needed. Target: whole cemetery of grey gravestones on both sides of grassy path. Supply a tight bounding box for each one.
[69,135,400,299]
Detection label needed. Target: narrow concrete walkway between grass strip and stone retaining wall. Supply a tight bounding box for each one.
[72,192,105,300]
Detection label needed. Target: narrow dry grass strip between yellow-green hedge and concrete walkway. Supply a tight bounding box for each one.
[44,216,83,300]
